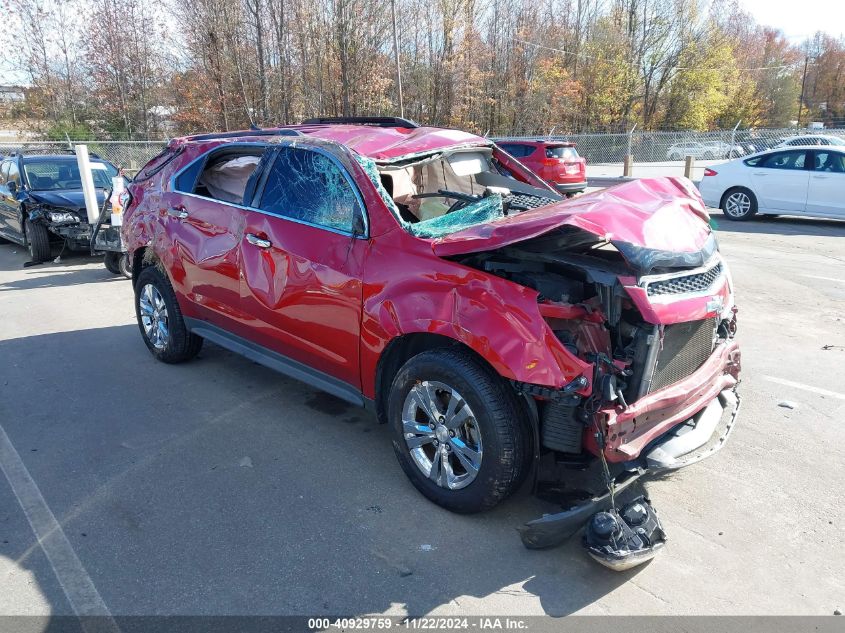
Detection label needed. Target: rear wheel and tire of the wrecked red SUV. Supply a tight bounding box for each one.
[135,266,203,363]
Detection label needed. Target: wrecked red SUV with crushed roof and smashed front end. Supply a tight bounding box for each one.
[122,118,740,512]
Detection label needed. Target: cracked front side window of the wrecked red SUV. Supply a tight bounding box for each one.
[259,147,363,233]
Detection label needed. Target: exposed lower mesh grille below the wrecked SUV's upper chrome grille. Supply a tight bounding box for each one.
[650,319,716,391]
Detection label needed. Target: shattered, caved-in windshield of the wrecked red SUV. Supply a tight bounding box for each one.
[358,147,560,238]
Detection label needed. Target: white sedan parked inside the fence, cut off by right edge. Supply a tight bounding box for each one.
[698,145,845,220]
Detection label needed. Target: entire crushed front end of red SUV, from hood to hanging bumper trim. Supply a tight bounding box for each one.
[438,179,740,548]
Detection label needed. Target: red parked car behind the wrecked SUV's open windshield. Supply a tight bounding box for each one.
[497,139,587,194]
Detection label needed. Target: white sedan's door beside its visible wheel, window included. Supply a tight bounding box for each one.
[751,150,810,214]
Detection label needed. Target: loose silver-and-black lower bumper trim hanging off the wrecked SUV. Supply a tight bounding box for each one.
[518,386,740,549]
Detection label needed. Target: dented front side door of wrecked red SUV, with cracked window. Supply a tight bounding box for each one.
[241,144,368,389]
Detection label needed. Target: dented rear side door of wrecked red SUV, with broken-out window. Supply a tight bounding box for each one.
[161,144,268,335]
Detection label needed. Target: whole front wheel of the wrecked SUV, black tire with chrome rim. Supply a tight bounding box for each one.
[387,348,532,513]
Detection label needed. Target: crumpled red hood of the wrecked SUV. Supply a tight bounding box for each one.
[431,178,715,272]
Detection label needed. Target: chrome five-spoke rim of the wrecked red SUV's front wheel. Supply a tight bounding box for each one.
[402,380,483,490]
